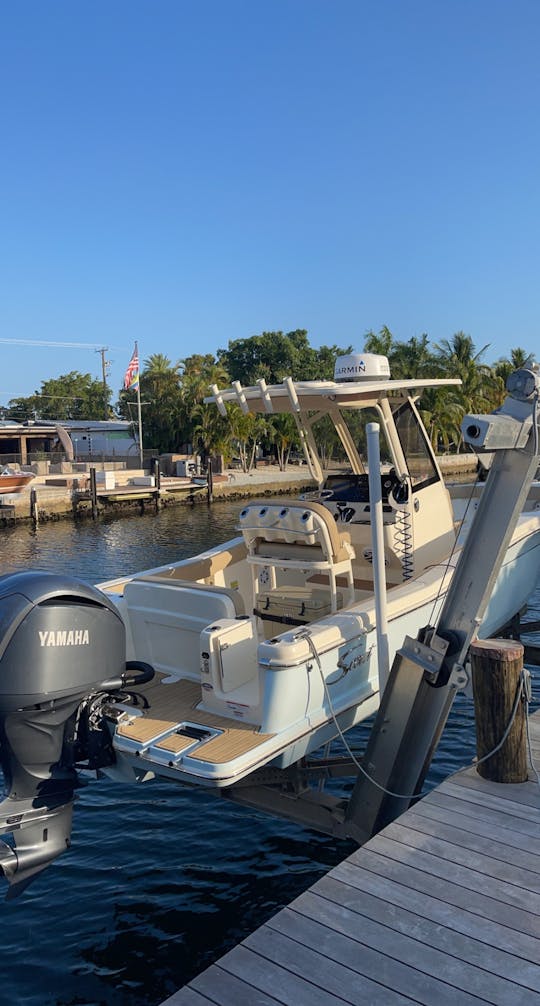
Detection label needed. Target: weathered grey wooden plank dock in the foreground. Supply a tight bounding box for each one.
[163,711,540,1006]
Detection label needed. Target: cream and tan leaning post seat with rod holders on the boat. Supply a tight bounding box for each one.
[238,500,355,612]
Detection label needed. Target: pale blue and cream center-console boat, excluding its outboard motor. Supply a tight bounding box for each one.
[93,354,540,787]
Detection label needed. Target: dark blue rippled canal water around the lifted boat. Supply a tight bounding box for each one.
[0,503,540,1006]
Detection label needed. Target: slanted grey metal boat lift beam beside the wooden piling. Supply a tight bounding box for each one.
[345,361,540,843]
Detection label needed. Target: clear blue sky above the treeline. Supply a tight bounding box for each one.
[0,0,540,403]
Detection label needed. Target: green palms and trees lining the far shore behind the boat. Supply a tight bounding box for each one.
[0,326,529,471]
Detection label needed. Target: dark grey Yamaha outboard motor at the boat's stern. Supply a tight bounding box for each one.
[0,572,154,896]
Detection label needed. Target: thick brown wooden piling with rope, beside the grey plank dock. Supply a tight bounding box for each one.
[471,639,528,783]
